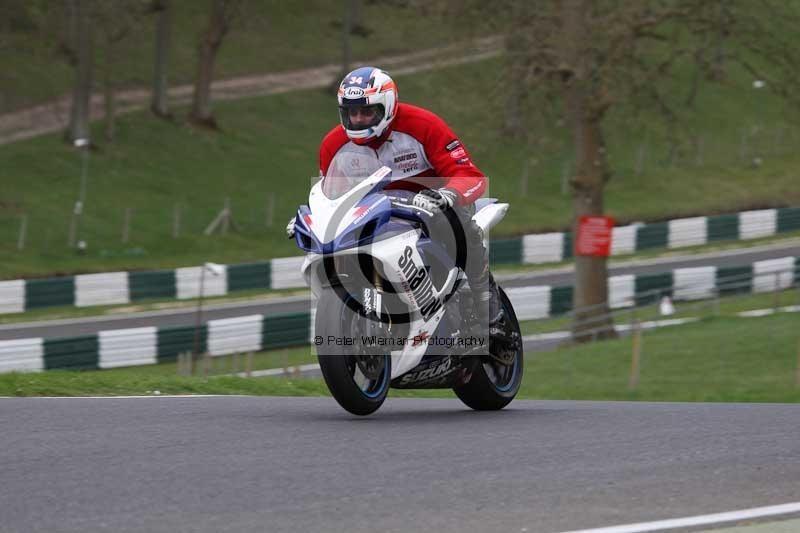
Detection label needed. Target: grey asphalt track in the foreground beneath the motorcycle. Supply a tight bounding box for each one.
[0,397,800,533]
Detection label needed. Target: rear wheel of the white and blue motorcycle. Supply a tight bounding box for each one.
[453,287,524,411]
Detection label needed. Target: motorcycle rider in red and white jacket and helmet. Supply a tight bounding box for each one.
[286,67,502,334]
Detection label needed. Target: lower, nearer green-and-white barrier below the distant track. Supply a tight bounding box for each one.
[0,257,800,372]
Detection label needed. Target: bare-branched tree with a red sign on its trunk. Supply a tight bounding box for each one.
[449,0,800,341]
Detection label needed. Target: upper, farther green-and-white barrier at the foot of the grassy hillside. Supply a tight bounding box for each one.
[0,207,800,313]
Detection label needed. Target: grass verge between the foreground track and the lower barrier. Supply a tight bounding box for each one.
[0,314,800,402]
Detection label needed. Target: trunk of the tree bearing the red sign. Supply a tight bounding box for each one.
[562,0,616,342]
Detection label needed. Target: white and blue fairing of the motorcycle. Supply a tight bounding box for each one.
[295,154,508,379]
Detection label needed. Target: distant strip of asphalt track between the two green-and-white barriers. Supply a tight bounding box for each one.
[0,239,800,340]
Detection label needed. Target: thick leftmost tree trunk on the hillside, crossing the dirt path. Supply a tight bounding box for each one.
[66,0,94,143]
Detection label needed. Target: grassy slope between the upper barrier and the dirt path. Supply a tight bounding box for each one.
[0,58,800,279]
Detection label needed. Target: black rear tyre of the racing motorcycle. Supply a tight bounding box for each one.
[453,287,524,411]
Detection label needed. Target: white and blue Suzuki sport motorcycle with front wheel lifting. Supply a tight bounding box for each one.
[294,152,523,415]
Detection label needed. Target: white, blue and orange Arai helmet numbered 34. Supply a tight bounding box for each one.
[338,67,397,144]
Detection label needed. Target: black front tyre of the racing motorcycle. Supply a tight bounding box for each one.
[314,290,392,416]
